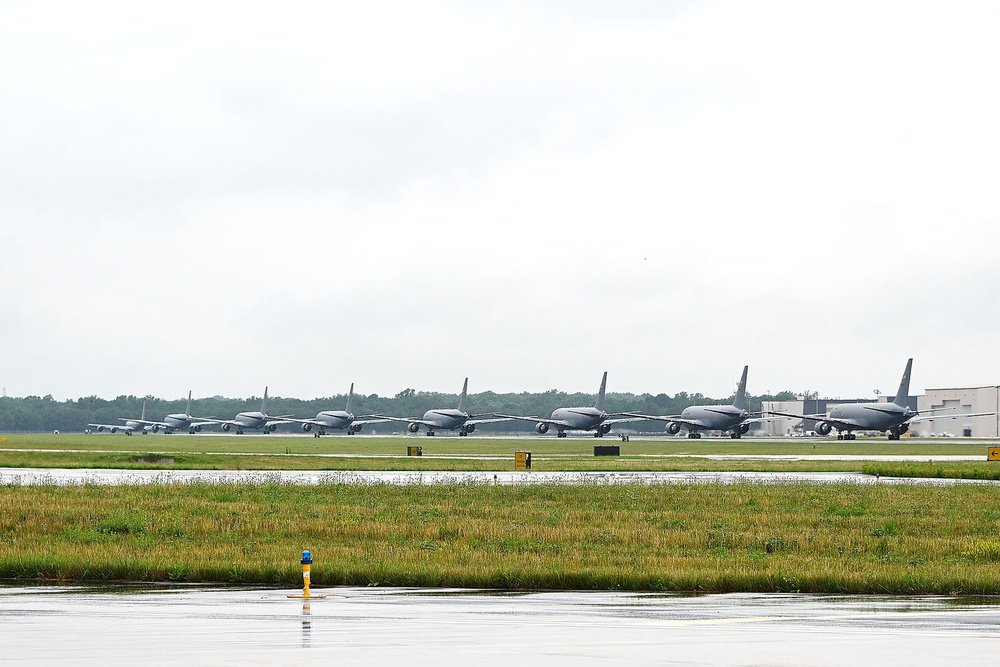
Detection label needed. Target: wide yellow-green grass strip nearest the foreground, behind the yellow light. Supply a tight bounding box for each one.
[0,479,1000,594]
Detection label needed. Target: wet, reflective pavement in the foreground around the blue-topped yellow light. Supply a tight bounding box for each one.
[0,586,1000,667]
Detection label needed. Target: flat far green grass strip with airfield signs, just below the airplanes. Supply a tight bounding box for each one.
[0,434,1000,479]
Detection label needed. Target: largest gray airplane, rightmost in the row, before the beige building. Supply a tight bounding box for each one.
[769,358,996,440]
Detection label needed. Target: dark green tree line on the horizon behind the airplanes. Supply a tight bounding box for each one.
[0,389,795,434]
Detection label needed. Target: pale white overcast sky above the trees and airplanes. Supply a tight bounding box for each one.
[0,0,1000,400]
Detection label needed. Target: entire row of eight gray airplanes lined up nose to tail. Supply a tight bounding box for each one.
[88,359,996,440]
